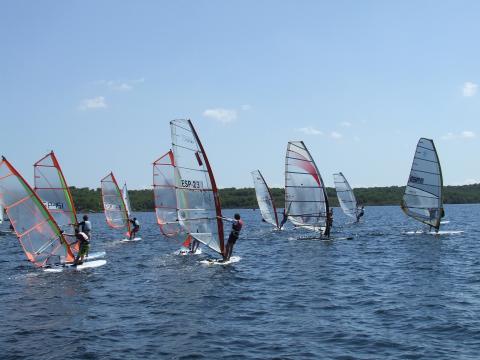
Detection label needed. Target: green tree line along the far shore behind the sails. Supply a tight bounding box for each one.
[71,184,480,212]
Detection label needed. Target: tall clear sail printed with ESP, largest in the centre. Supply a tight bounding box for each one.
[170,120,224,254]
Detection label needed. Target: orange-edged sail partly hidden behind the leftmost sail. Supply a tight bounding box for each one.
[33,151,77,234]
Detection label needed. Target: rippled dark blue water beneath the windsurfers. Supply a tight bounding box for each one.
[0,205,480,359]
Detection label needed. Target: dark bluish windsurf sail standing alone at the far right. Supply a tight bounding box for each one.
[402,138,444,231]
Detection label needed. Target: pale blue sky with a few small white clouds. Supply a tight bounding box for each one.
[0,0,480,189]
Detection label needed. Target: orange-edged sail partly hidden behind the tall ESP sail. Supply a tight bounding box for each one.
[153,150,182,237]
